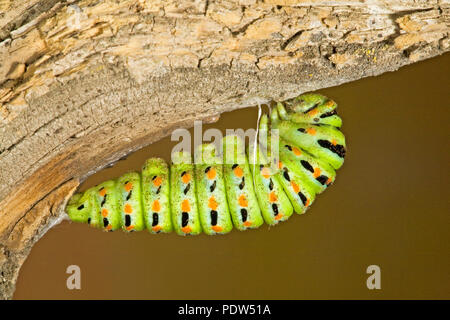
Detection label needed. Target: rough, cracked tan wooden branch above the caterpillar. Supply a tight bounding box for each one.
[0,0,450,298]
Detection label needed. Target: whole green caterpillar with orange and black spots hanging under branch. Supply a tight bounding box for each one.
[66,93,346,235]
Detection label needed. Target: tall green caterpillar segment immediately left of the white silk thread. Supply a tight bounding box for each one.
[222,135,264,230]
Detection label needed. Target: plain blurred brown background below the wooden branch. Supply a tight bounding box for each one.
[15,54,450,299]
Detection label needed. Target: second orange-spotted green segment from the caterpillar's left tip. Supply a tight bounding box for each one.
[117,172,145,232]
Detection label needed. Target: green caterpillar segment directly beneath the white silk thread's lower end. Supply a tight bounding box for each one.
[248,147,294,225]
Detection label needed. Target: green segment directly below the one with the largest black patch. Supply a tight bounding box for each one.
[280,139,336,193]
